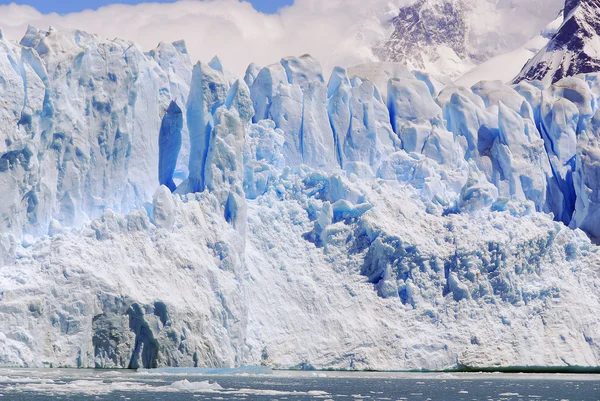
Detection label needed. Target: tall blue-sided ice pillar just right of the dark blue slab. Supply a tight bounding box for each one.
[177,59,255,236]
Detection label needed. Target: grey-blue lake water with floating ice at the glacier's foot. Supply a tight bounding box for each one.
[0,369,600,401]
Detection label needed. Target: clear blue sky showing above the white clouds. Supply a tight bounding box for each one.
[0,0,293,14]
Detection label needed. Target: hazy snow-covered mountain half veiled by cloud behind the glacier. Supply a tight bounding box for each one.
[375,0,564,79]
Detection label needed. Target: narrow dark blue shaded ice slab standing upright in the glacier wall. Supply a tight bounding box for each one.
[158,101,183,192]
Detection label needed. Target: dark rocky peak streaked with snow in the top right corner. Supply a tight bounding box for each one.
[515,0,600,83]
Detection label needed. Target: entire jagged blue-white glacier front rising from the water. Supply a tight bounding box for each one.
[0,27,600,370]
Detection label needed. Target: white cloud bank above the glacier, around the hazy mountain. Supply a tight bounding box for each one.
[0,0,562,74]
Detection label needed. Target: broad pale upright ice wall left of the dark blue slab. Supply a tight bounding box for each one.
[0,27,169,238]
